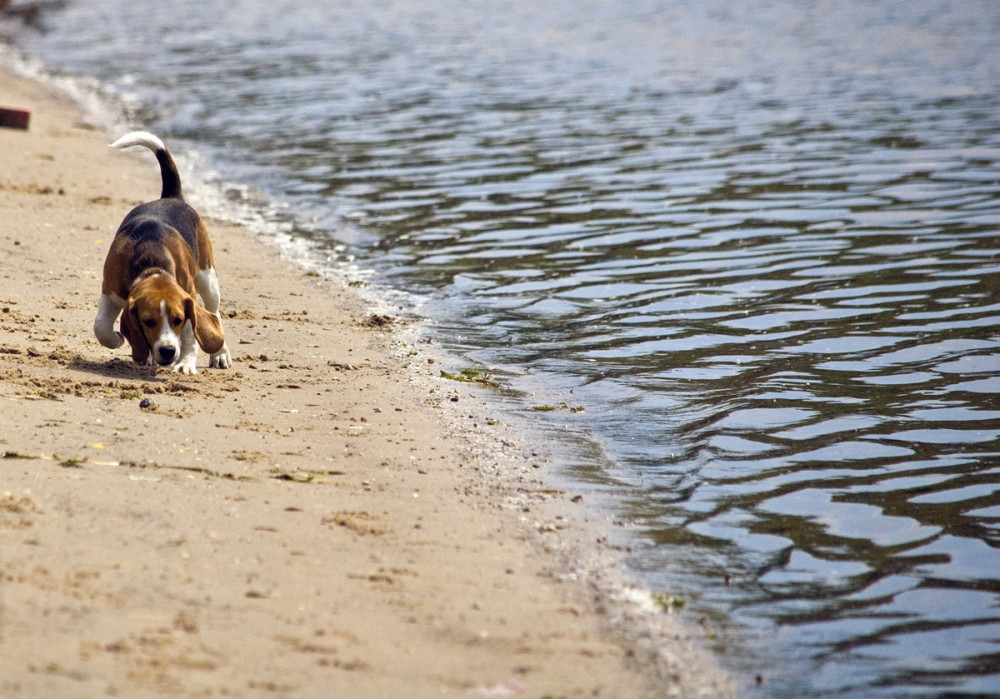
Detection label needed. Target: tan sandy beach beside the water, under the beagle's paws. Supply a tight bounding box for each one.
[0,64,731,697]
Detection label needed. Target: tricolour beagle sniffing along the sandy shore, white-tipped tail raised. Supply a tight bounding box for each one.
[94,131,232,374]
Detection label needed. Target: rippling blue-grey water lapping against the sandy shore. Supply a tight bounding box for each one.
[7,0,1000,696]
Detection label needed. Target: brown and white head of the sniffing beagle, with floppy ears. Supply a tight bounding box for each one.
[121,273,225,366]
